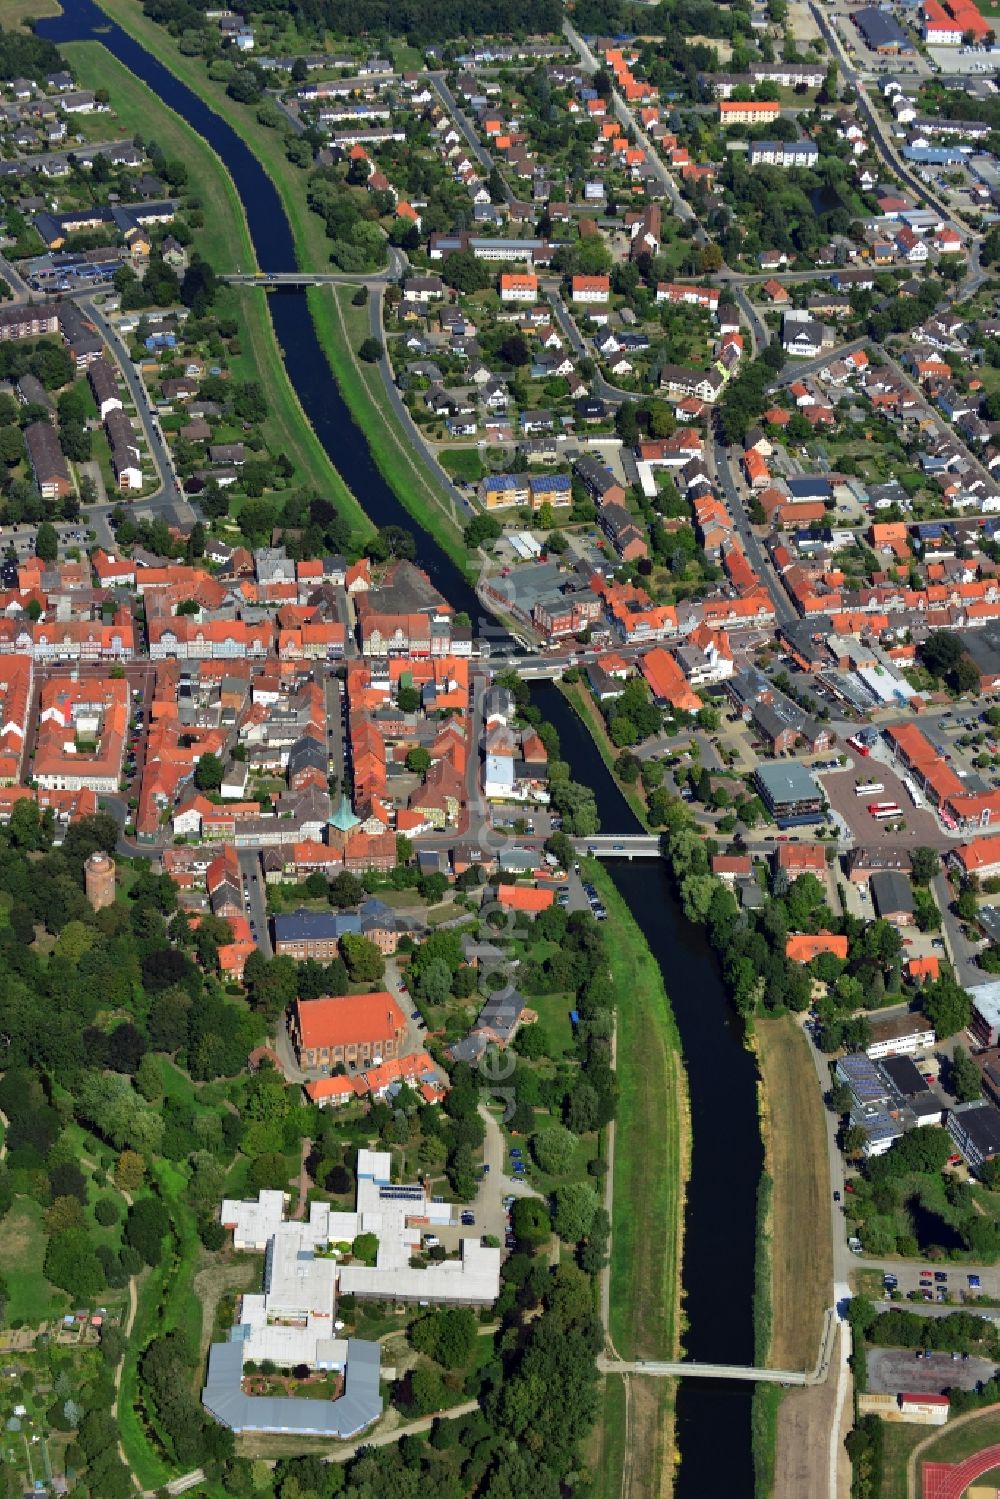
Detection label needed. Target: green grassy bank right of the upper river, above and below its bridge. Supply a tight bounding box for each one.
[97,0,475,554]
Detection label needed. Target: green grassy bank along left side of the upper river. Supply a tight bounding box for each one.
[63,42,372,541]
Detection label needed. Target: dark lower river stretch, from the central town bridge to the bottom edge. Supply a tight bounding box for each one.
[532,684,763,1499]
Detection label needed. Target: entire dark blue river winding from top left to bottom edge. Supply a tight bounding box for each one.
[37,0,762,1499]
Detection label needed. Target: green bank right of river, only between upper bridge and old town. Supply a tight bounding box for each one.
[309,286,478,580]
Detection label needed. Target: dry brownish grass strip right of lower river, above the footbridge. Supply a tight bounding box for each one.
[756,1016,834,1369]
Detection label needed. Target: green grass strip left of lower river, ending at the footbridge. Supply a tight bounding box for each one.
[586,860,690,1360]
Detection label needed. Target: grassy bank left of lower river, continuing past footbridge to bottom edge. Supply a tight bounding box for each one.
[586,860,691,1499]
